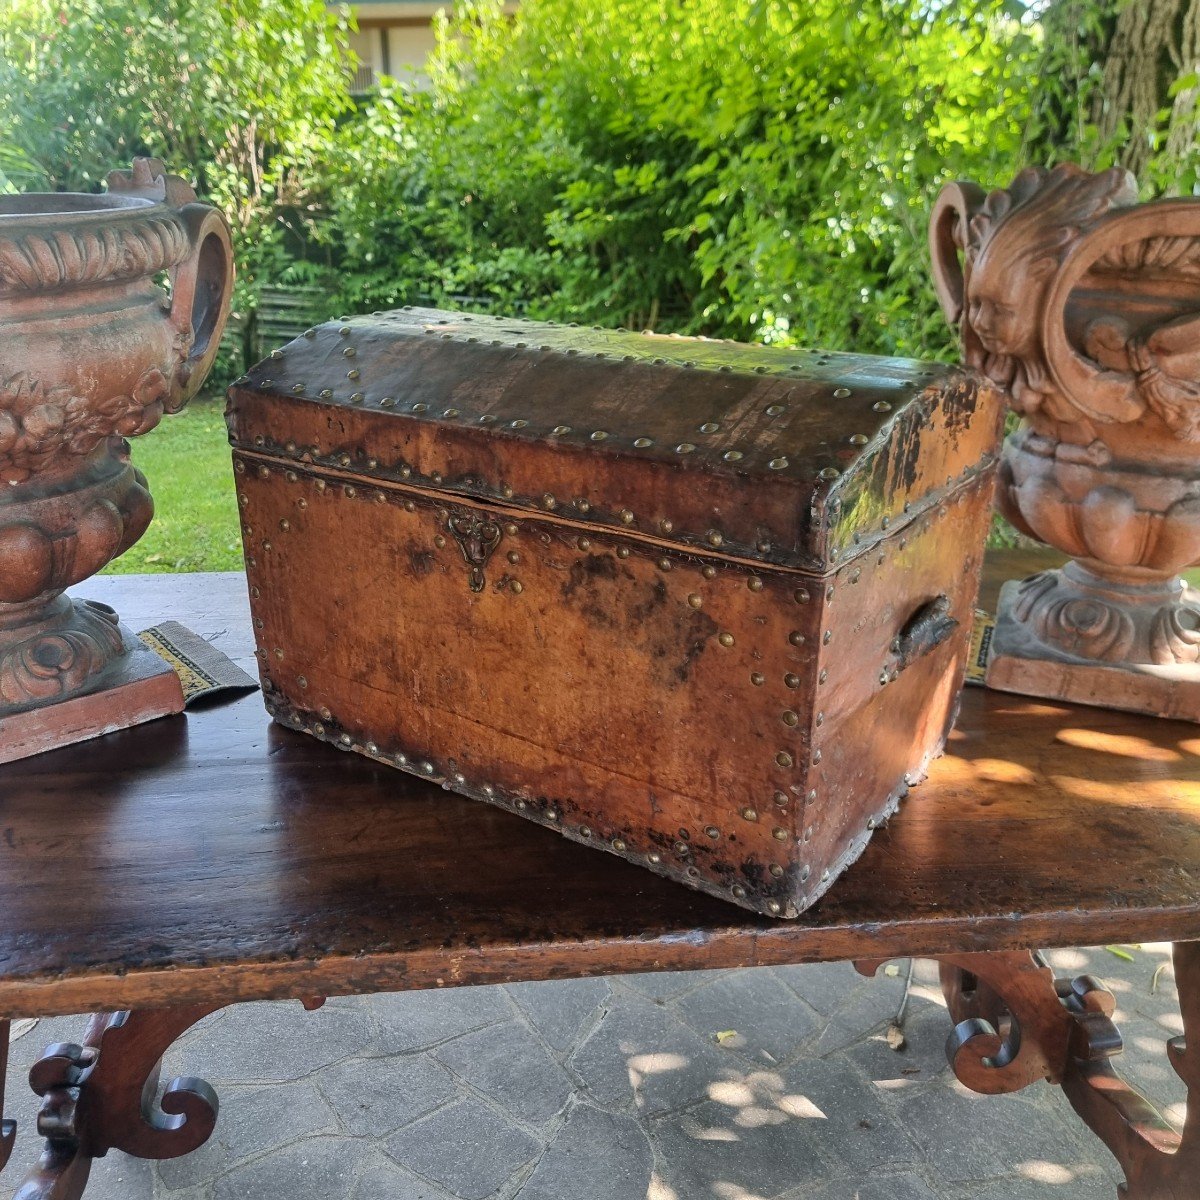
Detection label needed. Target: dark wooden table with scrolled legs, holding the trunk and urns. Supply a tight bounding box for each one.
[0,556,1200,1200]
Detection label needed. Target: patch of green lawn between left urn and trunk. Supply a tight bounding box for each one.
[106,396,242,575]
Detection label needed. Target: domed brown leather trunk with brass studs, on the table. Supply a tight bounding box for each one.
[229,308,1003,917]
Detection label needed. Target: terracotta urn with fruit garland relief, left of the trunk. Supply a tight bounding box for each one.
[0,158,233,762]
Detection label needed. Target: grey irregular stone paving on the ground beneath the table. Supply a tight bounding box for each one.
[0,946,1184,1200]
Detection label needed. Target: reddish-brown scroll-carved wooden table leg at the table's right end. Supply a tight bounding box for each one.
[856,942,1200,1200]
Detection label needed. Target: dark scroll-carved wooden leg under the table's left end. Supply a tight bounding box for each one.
[11,998,323,1200]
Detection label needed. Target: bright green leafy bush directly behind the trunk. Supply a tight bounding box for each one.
[314,0,1038,353]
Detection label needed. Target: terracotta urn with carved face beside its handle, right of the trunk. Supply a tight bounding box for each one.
[930,164,1200,721]
